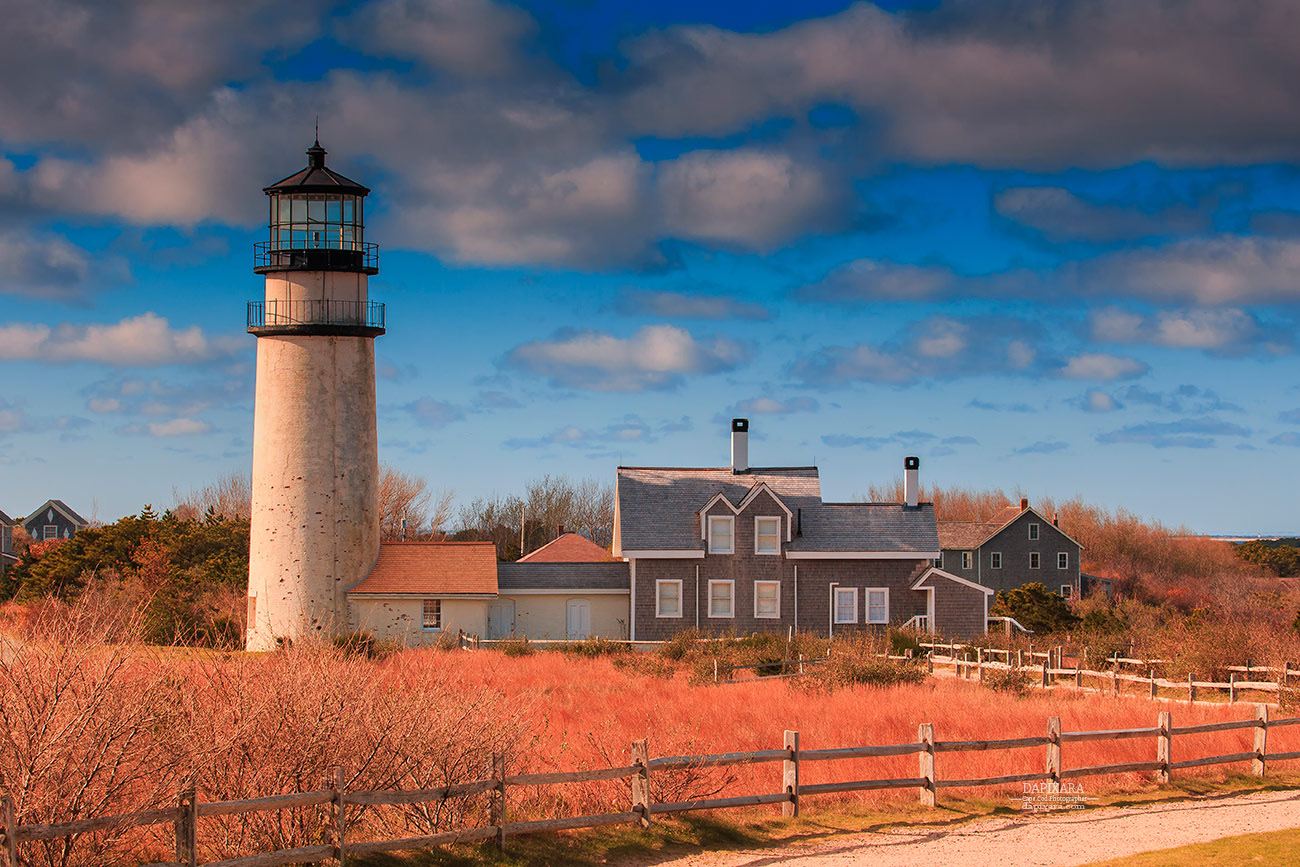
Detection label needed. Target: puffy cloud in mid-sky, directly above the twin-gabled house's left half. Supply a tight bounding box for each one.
[506,325,749,391]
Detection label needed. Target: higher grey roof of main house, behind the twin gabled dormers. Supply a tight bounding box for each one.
[616,467,822,551]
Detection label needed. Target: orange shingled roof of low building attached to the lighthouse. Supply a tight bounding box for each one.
[347,542,497,597]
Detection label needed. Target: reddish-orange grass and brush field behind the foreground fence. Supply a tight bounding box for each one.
[0,606,1284,867]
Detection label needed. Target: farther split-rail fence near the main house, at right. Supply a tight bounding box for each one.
[922,643,1300,703]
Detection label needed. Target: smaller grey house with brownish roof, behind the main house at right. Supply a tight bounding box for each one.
[937,499,1083,598]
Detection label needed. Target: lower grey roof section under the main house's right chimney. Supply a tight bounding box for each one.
[789,503,939,552]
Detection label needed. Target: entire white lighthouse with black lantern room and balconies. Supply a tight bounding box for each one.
[246,140,385,650]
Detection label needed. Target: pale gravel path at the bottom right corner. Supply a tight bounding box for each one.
[644,792,1300,867]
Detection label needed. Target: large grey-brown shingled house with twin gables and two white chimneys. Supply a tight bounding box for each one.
[614,419,993,641]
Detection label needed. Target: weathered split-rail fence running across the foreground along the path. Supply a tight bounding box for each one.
[0,706,1300,867]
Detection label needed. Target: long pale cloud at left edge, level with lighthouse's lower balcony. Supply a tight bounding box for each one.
[0,313,243,367]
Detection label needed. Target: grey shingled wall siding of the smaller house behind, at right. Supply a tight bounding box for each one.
[944,512,1082,593]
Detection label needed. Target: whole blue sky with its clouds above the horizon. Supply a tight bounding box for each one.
[0,0,1300,533]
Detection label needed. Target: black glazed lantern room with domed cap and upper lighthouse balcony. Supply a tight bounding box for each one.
[254,140,380,274]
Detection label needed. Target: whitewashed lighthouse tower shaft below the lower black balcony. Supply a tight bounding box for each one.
[246,334,380,650]
